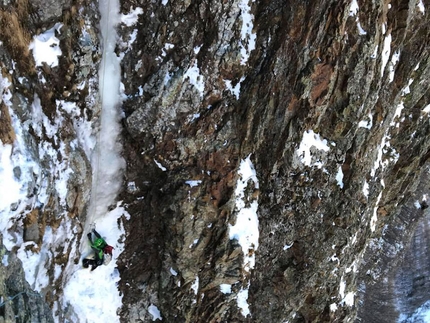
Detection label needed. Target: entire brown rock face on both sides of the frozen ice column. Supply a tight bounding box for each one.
[0,0,430,322]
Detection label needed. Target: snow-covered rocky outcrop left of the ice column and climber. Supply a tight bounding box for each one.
[0,0,99,322]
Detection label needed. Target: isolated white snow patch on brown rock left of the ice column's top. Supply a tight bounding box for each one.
[29,23,63,67]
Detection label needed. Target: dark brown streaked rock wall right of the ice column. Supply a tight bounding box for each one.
[116,1,429,322]
